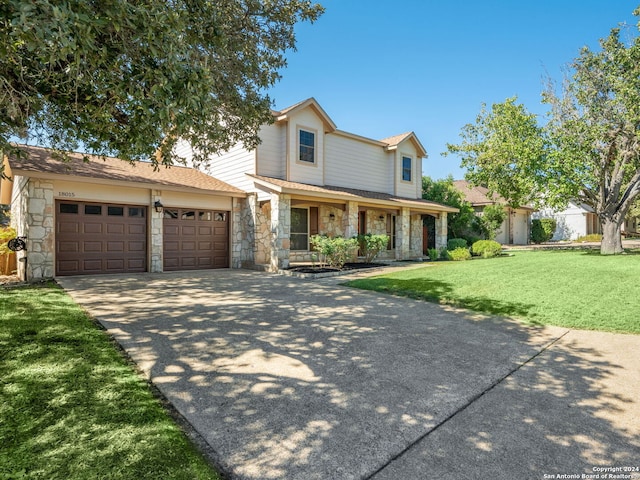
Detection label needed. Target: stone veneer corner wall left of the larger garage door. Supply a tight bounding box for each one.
[12,177,55,282]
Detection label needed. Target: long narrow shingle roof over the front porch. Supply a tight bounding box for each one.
[247,174,458,212]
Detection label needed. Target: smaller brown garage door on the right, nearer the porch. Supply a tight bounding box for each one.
[163,207,229,271]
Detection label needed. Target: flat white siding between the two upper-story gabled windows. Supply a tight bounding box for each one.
[325,134,393,193]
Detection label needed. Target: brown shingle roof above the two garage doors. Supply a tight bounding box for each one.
[9,145,245,196]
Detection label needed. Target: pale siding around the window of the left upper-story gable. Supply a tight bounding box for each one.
[287,109,324,185]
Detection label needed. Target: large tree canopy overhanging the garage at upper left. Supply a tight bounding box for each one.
[0,0,323,172]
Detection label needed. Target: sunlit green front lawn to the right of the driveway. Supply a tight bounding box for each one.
[348,251,640,334]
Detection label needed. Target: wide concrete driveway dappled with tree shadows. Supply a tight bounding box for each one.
[59,270,640,480]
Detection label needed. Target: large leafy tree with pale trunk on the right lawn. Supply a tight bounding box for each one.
[448,10,640,254]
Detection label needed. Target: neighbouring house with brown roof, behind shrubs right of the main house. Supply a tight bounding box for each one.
[453,180,534,245]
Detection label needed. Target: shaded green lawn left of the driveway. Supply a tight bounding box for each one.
[0,285,220,480]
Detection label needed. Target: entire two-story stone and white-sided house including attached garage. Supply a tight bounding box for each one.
[0,99,457,281]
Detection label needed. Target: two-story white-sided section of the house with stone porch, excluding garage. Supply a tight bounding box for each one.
[180,98,457,270]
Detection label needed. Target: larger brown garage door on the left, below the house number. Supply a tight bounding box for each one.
[56,200,147,275]
